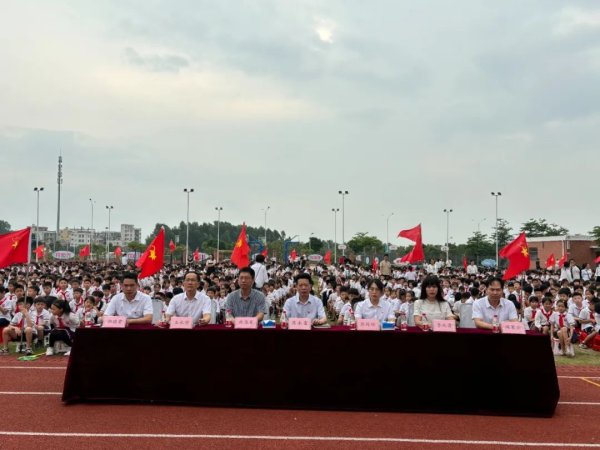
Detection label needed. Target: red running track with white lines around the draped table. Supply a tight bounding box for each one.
[0,356,600,450]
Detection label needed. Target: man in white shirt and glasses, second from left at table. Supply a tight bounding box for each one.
[166,271,212,325]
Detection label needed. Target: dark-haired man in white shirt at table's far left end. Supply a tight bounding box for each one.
[104,272,152,325]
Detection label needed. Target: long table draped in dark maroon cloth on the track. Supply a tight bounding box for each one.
[62,326,560,417]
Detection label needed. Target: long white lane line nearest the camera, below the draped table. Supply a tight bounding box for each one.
[0,431,600,448]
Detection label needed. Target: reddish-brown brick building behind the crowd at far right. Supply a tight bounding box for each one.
[527,234,600,269]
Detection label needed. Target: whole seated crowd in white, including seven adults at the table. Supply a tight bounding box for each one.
[0,255,600,355]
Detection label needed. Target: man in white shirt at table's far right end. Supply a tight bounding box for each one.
[473,278,518,330]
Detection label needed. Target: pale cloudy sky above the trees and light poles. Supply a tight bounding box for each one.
[0,0,600,245]
